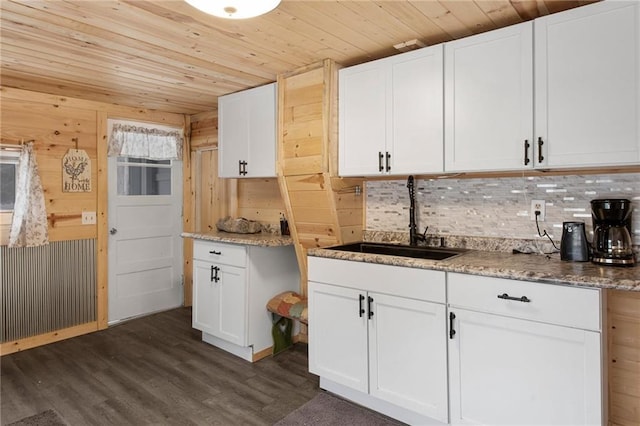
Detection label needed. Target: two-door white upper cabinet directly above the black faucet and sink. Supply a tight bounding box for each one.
[339,45,443,176]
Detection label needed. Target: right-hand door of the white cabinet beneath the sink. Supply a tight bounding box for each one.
[369,293,449,423]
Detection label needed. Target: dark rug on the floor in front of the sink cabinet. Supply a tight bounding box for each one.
[274,392,404,426]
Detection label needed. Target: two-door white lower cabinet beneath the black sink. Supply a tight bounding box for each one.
[308,257,448,424]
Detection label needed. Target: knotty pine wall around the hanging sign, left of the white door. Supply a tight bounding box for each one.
[0,86,188,354]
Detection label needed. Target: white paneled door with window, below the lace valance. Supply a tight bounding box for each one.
[108,125,183,324]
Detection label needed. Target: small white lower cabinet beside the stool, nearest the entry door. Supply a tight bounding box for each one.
[192,240,300,361]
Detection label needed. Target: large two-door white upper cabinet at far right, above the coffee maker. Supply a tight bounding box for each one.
[444,1,640,172]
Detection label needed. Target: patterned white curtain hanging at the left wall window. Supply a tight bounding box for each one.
[9,142,49,247]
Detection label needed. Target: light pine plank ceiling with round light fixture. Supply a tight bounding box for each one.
[0,0,593,114]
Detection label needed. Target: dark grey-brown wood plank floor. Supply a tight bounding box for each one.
[0,308,318,425]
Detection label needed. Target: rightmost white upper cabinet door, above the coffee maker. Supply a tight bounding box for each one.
[535,2,640,167]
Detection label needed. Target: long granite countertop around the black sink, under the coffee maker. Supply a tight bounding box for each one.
[308,248,640,291]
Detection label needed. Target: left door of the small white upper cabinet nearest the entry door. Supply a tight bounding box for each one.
[218,92,249,178]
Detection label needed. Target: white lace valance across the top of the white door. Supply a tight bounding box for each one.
[107,123,184,160]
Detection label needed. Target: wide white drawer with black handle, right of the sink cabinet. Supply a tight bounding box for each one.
[447,273,601,331]
